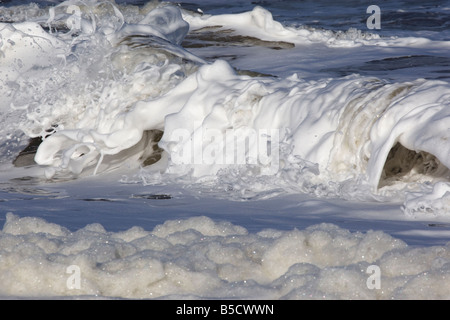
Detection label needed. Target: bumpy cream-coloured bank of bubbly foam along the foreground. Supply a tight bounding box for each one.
[0,213,450,299]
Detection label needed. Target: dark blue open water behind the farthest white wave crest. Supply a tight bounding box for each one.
[0,0,450,35]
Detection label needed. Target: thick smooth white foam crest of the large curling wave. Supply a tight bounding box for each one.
[29,51,450,199]
